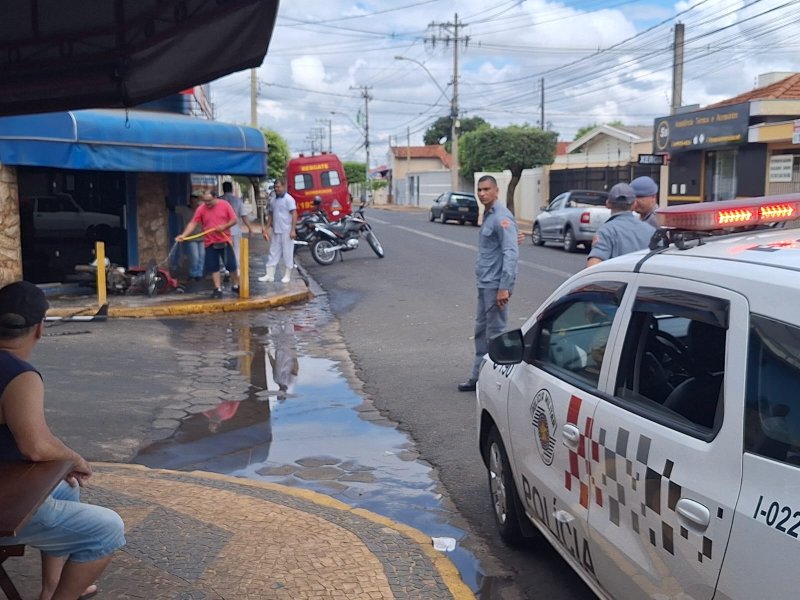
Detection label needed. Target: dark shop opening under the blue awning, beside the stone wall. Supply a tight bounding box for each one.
[17,167,128,283]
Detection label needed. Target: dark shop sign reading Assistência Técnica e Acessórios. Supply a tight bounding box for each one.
[654,102,750,154]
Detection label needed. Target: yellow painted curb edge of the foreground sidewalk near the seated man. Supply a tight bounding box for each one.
[91,462,475,600]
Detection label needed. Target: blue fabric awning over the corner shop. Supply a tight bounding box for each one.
[0,110,267,176]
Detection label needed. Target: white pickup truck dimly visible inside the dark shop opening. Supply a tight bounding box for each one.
[22,193,120,238]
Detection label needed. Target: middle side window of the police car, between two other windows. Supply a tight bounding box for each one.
[615,288,728,439]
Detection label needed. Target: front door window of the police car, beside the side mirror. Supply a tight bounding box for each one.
[526,283,624,387]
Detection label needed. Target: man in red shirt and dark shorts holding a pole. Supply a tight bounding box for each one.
[175,192,239,298]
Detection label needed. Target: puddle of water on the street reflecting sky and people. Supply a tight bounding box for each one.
[134,304,485,593]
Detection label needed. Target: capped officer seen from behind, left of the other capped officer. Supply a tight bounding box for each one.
[586,183,654,267]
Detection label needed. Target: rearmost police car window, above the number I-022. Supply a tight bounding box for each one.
[745,315,800,465]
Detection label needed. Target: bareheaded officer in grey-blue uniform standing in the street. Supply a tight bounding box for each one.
[458,175,519,392]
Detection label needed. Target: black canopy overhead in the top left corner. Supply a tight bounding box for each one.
[0,0,278,115]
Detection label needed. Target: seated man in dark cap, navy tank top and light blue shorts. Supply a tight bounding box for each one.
[0,281,125,600]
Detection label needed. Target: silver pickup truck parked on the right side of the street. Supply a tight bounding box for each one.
[531,190,611,252]
